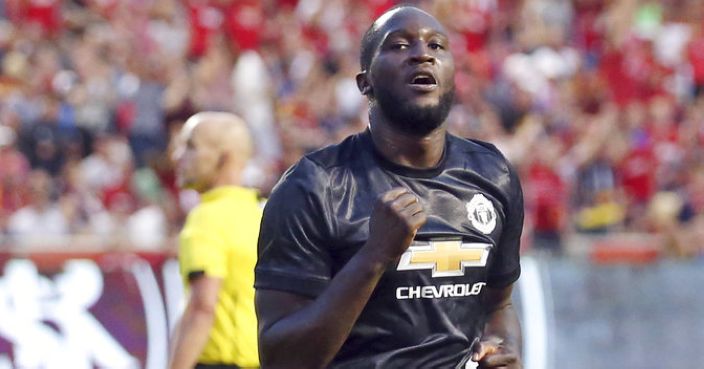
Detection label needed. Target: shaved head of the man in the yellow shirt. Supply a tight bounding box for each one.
[174,112,253,192]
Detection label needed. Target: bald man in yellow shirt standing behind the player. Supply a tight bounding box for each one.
[169,112,262,369]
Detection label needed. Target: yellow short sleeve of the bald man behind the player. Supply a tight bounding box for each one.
[179,209,228,279]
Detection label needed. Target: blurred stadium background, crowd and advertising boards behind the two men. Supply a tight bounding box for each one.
[0,0,704,369]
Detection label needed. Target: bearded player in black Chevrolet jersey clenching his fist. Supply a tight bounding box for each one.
[255,6,523,369]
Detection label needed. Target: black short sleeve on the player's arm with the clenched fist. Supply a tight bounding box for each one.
[254,158,332,297]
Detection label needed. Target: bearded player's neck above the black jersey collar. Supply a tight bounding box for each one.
[369,110,447,169]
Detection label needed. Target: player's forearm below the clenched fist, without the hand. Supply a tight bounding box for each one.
[260,244,386,369]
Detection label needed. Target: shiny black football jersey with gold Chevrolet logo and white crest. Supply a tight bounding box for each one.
[255,130,523,368]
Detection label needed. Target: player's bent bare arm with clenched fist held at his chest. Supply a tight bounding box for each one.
[255,181,426,369]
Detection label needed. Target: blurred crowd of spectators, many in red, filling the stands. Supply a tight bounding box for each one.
[0,0,704,257]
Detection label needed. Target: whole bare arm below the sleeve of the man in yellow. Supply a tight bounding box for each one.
[169,273,222,369]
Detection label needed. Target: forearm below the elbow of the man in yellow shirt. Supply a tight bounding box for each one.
[169,306,214,369]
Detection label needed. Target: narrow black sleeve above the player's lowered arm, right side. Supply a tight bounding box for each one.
[487,163,524,288]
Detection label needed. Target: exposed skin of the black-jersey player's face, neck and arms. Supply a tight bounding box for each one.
[255,8,521,369]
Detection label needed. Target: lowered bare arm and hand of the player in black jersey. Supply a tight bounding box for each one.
[472,284,523,369]
